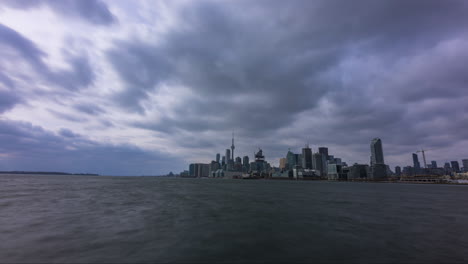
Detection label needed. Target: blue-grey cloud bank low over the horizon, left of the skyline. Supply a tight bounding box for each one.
[0,120,182,175]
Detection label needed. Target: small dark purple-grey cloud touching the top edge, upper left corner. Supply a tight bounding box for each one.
[0,0,117,25]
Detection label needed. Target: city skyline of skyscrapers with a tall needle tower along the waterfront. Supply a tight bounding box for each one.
[181,135,468,181]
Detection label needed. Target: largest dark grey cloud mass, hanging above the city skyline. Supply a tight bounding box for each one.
[108,0,468,166]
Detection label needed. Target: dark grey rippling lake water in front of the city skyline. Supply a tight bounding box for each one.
[0,175,468,263]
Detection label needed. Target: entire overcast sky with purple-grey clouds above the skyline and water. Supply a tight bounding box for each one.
[0,0,468,175]
